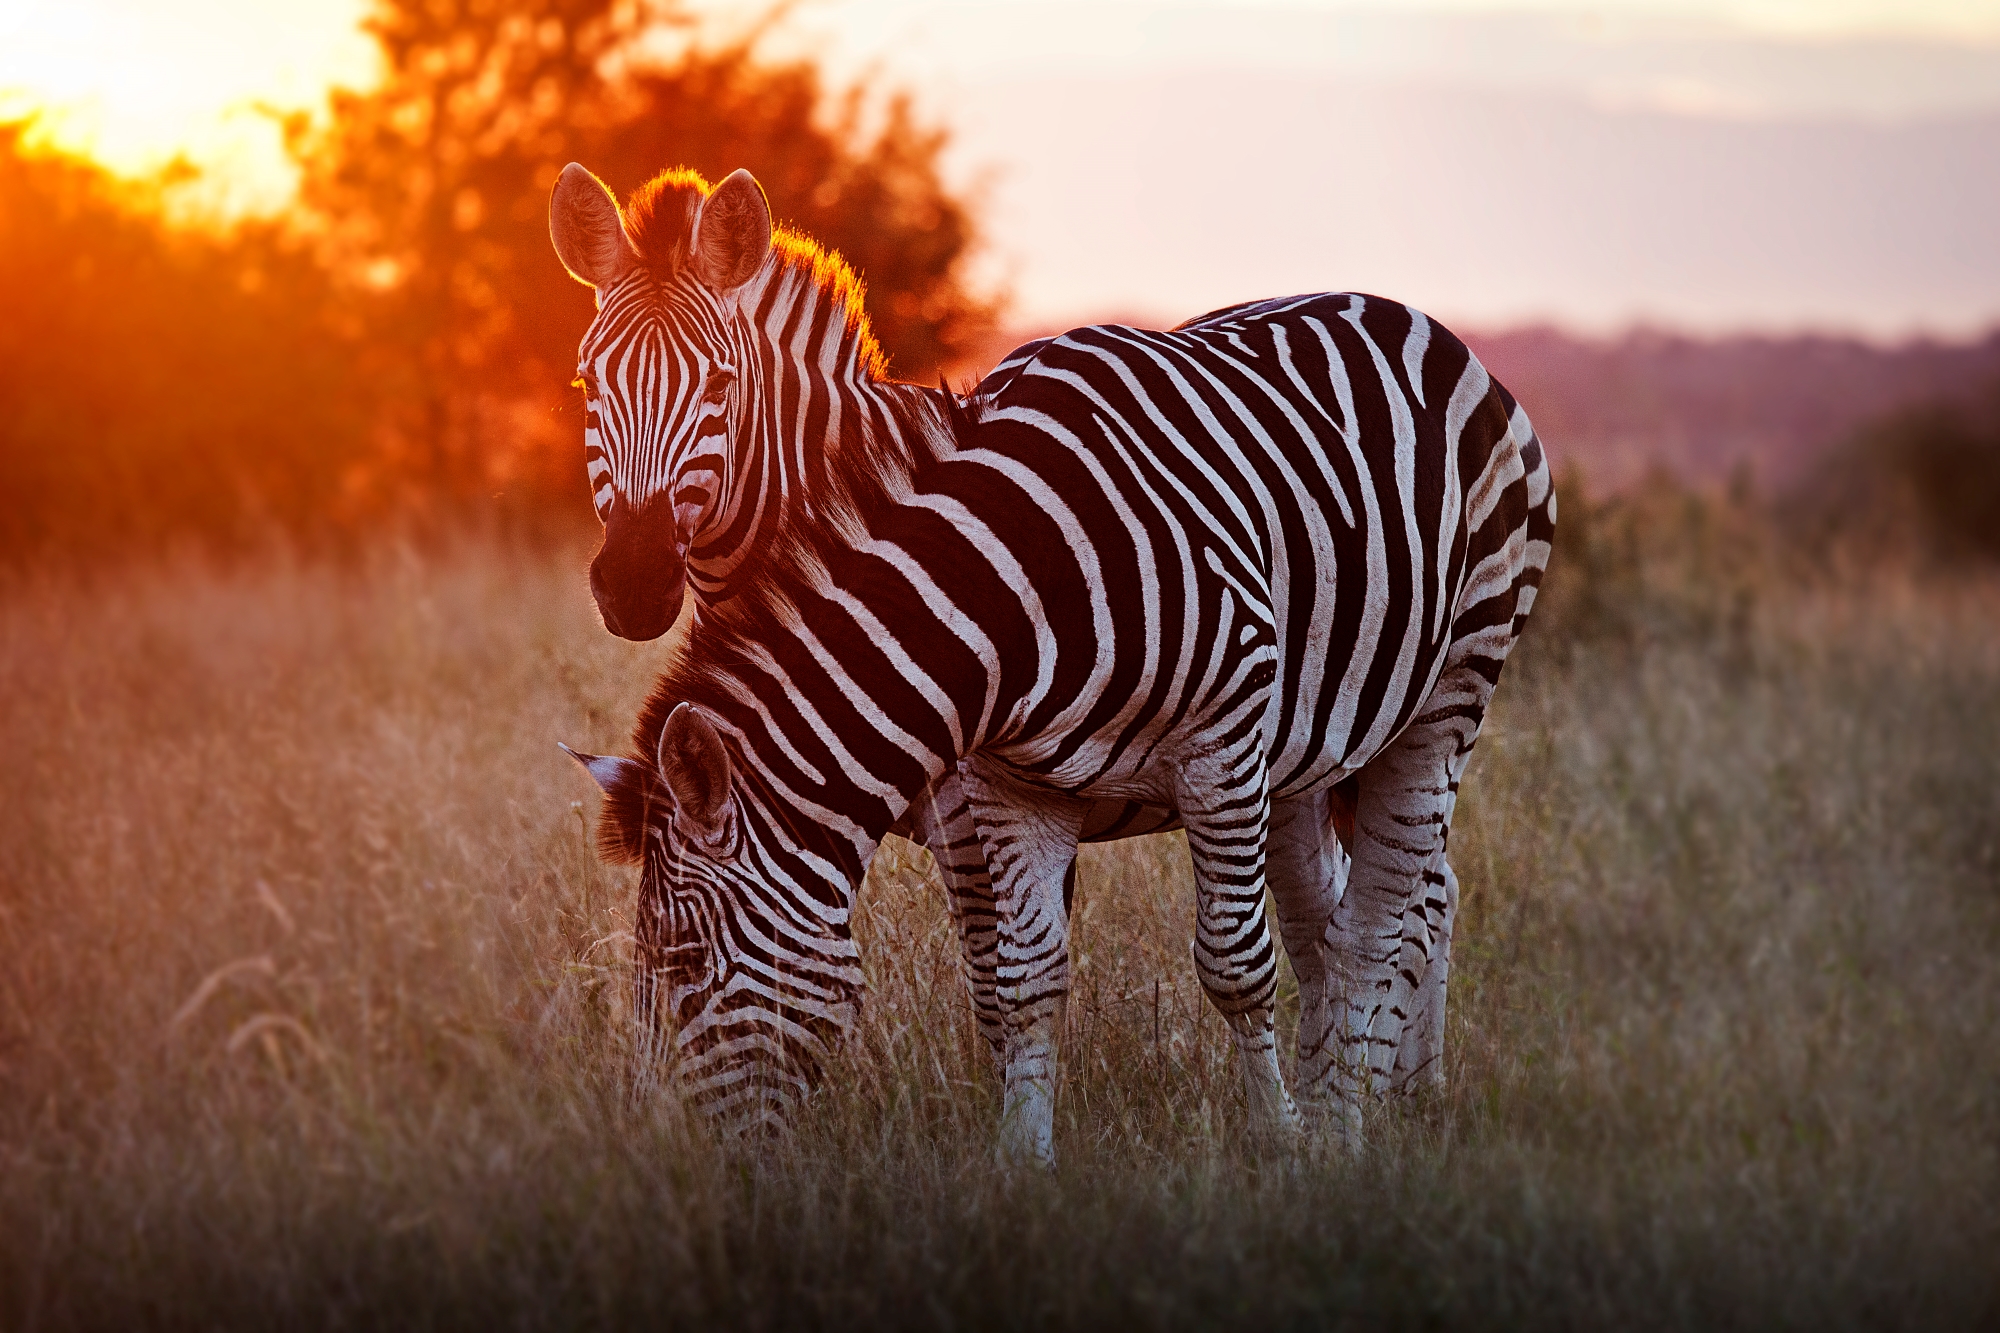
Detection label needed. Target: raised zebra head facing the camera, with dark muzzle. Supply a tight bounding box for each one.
[548,162,772,638]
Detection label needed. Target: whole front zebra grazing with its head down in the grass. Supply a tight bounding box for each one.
[556,169,1554,1159]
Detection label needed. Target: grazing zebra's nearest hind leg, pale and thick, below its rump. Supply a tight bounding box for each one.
[1328,667,1492,1107]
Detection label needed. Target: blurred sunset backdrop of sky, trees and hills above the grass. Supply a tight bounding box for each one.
[0,0,2000,564]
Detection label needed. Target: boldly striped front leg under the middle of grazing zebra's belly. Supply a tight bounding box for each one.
[1176,751,1298,1135]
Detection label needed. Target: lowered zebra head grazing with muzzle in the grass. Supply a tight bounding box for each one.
[564,703,864,1129]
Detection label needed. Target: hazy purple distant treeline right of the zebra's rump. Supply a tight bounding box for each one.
[1468,328,2000,564]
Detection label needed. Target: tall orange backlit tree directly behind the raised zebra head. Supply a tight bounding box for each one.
[290,0,992,504]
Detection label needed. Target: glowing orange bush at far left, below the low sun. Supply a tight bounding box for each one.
[0,122,370,560]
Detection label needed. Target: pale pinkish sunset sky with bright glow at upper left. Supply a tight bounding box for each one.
[11,0,2000,338]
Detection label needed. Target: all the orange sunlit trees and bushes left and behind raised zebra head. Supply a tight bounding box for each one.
[0,0,992,562]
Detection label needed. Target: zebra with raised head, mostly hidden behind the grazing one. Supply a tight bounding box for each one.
[550,164,1450,1085]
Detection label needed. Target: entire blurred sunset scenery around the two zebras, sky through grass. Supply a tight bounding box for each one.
[0,0,2000,1333]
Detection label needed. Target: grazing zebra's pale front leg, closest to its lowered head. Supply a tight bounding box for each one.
[960,757,1090,1165]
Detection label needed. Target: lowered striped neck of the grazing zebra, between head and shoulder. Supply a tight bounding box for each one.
[660,436,1064,883]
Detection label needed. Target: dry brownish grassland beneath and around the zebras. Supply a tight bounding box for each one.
[0,498,2000,1329]
